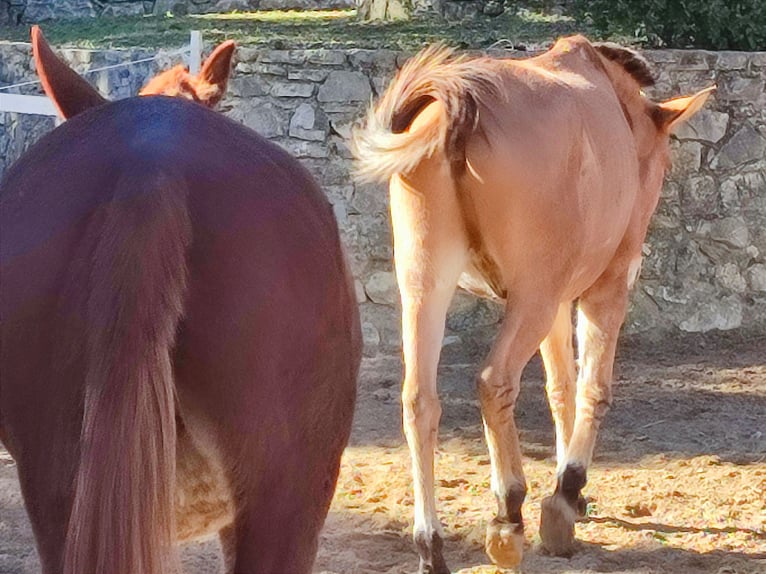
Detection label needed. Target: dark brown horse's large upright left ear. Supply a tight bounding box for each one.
[32,26,107,119]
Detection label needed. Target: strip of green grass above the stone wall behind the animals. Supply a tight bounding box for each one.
[0,9,594,50]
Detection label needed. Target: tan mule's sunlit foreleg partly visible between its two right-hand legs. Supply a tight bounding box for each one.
[540,301,577,472]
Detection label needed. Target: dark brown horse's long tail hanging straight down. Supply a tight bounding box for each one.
[64,172,191,574]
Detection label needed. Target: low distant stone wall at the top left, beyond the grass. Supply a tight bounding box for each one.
[0,0,354,25]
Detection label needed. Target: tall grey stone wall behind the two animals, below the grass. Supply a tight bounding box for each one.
[0,44,766,358]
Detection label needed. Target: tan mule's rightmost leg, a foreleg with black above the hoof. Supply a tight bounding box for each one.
[540,277,628,556]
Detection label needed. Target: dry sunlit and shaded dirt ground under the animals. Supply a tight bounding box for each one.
[0,330,766,574]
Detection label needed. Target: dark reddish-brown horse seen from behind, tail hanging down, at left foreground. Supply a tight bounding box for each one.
[0,30,361,574]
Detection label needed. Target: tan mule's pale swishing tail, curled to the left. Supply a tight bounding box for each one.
[353,45,501,181]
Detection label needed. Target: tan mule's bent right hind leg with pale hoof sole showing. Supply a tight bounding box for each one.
[477,304,553,568]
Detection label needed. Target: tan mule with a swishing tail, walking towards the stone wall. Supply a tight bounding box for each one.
[353,36,710,574]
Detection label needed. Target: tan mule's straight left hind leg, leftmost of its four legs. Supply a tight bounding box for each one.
[391,168,468,574]
